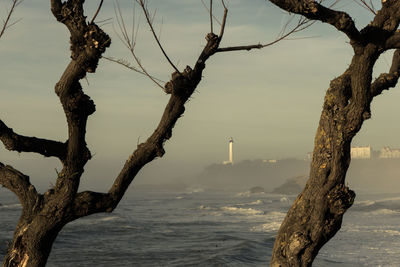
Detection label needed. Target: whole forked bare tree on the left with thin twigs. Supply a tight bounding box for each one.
[0,0,306,267]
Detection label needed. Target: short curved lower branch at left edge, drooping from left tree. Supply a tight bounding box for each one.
[0,162,40,213]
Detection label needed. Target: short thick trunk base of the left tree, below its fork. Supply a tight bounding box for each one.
[3,215,61,267]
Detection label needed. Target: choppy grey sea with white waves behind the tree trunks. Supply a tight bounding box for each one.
[0,187,400,267]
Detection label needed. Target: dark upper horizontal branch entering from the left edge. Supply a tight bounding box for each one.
[0,120,67,161]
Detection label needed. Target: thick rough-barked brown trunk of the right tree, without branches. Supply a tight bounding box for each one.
[271,50,376,267]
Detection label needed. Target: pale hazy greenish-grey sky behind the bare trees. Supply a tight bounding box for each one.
[0,0,400,192]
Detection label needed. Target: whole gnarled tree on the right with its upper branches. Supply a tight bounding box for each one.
[270,0,400,266]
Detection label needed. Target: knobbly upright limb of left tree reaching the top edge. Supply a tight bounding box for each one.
[51,0,111,201]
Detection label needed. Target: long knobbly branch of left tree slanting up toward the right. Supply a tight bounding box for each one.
[70,33,221,217]
